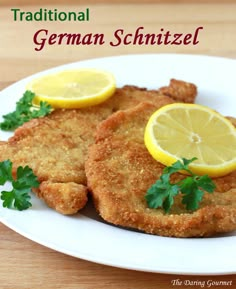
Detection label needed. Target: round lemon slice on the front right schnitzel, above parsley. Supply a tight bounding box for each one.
[144,103,236,177]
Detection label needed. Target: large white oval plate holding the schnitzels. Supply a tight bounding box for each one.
[0,54,236,275]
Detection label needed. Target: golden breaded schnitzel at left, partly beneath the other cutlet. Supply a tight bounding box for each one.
[0,81,197,214]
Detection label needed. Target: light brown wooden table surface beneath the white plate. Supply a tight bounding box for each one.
[0,1,236,289]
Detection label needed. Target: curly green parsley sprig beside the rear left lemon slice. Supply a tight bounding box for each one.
[0,90,52,131]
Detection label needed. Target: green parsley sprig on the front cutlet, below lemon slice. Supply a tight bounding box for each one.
[145,158,216,213]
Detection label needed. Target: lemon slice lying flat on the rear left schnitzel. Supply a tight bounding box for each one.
[27,68,116,108]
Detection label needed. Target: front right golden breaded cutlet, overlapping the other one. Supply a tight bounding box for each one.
[85,103,236,237]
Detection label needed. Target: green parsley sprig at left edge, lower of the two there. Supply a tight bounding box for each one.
[0,160,39,211]
